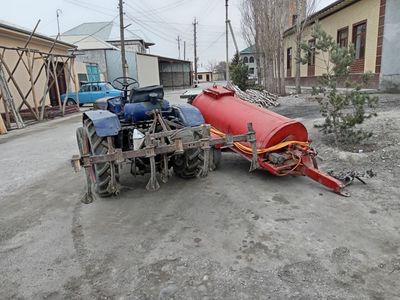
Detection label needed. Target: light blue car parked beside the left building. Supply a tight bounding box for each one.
[61,82,121,106]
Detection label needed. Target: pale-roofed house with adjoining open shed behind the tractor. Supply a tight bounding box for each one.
[60,22,192,88]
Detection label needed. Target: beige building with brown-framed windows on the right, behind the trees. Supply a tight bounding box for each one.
[284,0,400,91]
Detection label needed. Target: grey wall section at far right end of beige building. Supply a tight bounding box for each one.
[380,0,400,92]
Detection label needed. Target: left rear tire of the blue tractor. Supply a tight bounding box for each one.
[83,119,119,197]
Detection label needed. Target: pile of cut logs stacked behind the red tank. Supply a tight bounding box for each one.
[226,82,279,108]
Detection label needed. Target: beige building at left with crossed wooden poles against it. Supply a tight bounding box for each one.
[0,22,75,113]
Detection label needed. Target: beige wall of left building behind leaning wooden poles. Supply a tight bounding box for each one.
[0,28,69,113]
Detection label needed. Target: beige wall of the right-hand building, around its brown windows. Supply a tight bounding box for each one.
[284,0,378,77]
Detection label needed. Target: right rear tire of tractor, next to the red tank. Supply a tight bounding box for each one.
[172,130,203,179]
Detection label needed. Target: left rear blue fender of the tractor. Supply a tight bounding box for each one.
[83,109,121,137]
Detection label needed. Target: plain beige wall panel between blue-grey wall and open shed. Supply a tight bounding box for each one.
[136,53,160,87]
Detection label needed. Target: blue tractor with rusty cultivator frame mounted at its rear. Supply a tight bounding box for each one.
[72,77,256,203]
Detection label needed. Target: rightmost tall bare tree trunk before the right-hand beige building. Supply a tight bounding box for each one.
[295,0,316,94]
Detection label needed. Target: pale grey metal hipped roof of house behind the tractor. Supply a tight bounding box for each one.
[62,21,154,48]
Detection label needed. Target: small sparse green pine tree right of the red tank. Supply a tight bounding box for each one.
[301,23,378,146]
